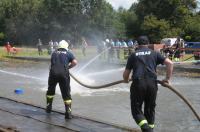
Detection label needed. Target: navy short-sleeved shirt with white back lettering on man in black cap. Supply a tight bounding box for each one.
[126,47,165,79]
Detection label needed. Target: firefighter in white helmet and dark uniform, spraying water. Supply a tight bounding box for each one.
[46,40,77,119]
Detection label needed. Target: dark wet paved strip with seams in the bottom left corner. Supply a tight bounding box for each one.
[0,98,136,132]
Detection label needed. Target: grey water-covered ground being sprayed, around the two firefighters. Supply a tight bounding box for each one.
[0,59,200,132]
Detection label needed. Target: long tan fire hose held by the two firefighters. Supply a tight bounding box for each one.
[70,73,200,121]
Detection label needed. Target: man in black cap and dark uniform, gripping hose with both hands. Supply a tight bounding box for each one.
[123,36,173,132]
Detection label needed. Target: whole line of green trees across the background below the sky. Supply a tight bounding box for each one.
[0,0,200,45]
